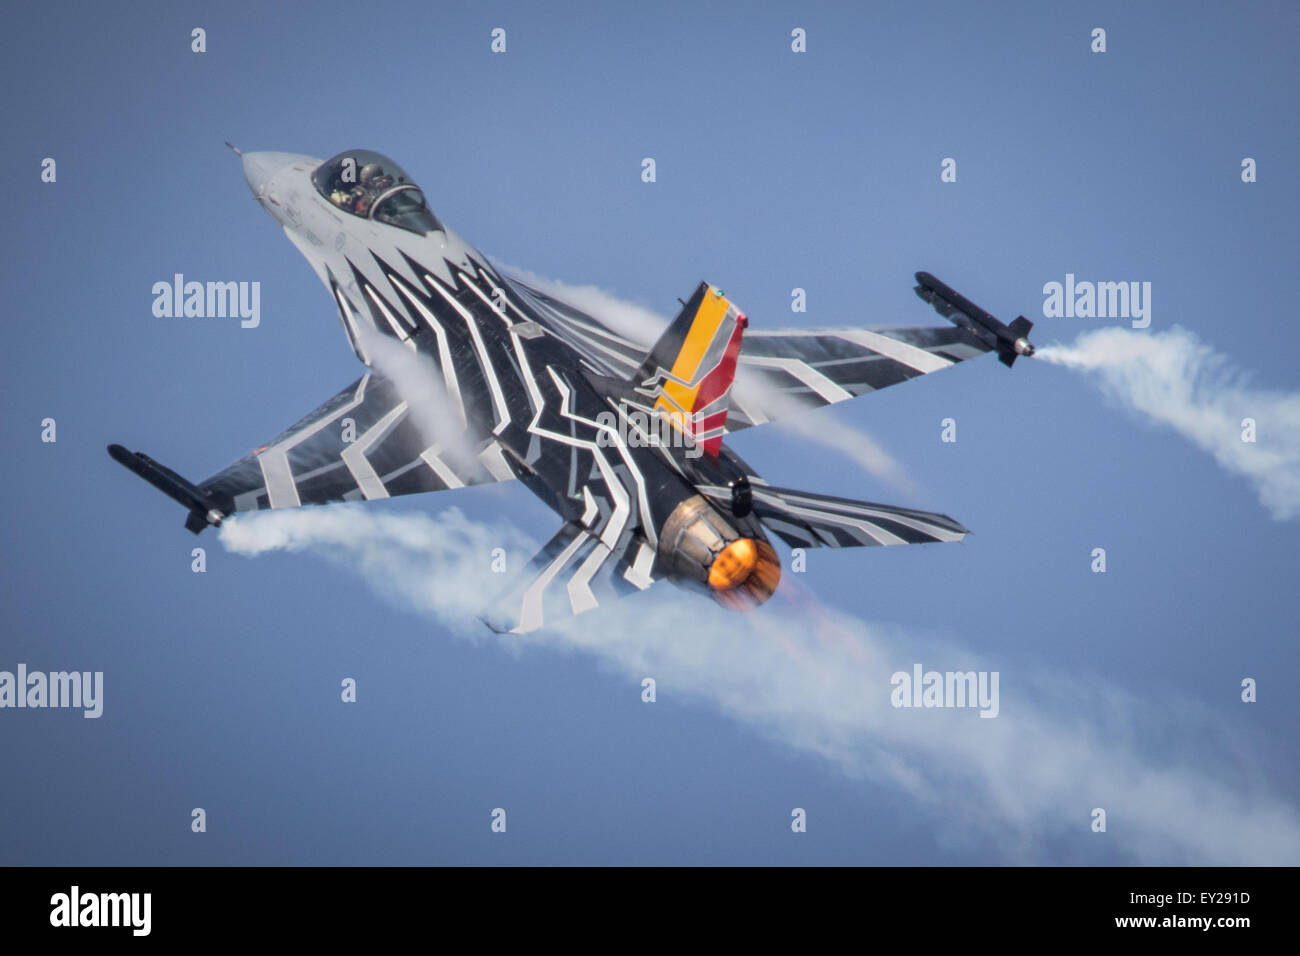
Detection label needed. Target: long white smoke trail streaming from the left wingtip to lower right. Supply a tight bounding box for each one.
[221,505,1300,865]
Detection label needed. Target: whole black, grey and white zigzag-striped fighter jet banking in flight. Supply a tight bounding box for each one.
[109,147,1034,632]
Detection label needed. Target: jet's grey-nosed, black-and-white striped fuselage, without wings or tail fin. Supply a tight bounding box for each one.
[243,152,776,613]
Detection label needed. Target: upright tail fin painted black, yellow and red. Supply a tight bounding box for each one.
[636,282,749,455]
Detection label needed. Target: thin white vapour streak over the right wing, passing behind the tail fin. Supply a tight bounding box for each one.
[498,264,917,493]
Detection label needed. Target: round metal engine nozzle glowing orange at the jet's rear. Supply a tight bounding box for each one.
[659,494,781,611]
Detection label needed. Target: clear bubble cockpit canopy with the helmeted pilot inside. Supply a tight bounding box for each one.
[312,150,442,235]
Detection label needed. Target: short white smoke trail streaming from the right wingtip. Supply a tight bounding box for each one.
[1037,326,1300,519]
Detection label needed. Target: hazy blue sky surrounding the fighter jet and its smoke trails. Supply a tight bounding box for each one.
[0,3,1300,864]
